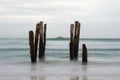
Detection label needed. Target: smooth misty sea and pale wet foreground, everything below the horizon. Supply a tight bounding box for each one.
[0,38,120,80]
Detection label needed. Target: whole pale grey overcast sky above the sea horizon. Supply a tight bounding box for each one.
[0,0,120,38]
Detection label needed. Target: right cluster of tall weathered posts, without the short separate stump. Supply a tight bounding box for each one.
[69,21,80,60]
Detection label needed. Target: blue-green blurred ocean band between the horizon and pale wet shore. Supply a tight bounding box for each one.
[0,38,120,63]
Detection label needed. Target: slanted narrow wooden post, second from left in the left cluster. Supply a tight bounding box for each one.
[35,23,40,59]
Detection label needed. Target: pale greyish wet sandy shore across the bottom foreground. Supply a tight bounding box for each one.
[0,61,120,80]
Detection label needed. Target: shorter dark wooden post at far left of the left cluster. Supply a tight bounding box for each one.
[29,31,36,63]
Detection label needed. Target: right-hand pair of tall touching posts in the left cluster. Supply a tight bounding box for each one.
[39,22,47,59]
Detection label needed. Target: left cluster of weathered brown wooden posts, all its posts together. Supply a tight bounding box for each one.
[29,21,47,63]
